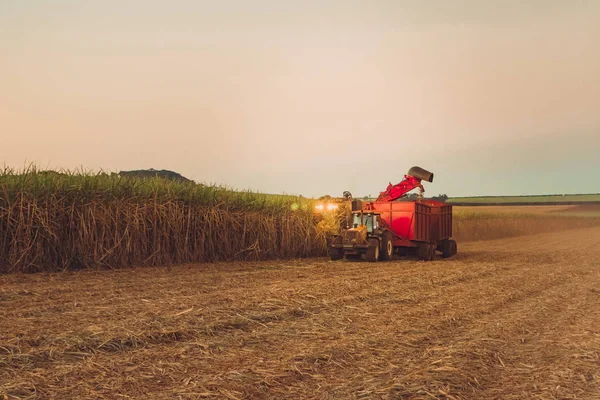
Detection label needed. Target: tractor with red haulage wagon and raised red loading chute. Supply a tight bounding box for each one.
[329,167,457,261]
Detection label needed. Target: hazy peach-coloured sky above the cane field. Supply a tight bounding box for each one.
[0,0,600,197]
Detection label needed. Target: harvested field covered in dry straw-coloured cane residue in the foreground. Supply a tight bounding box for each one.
[0,227,600,399]
